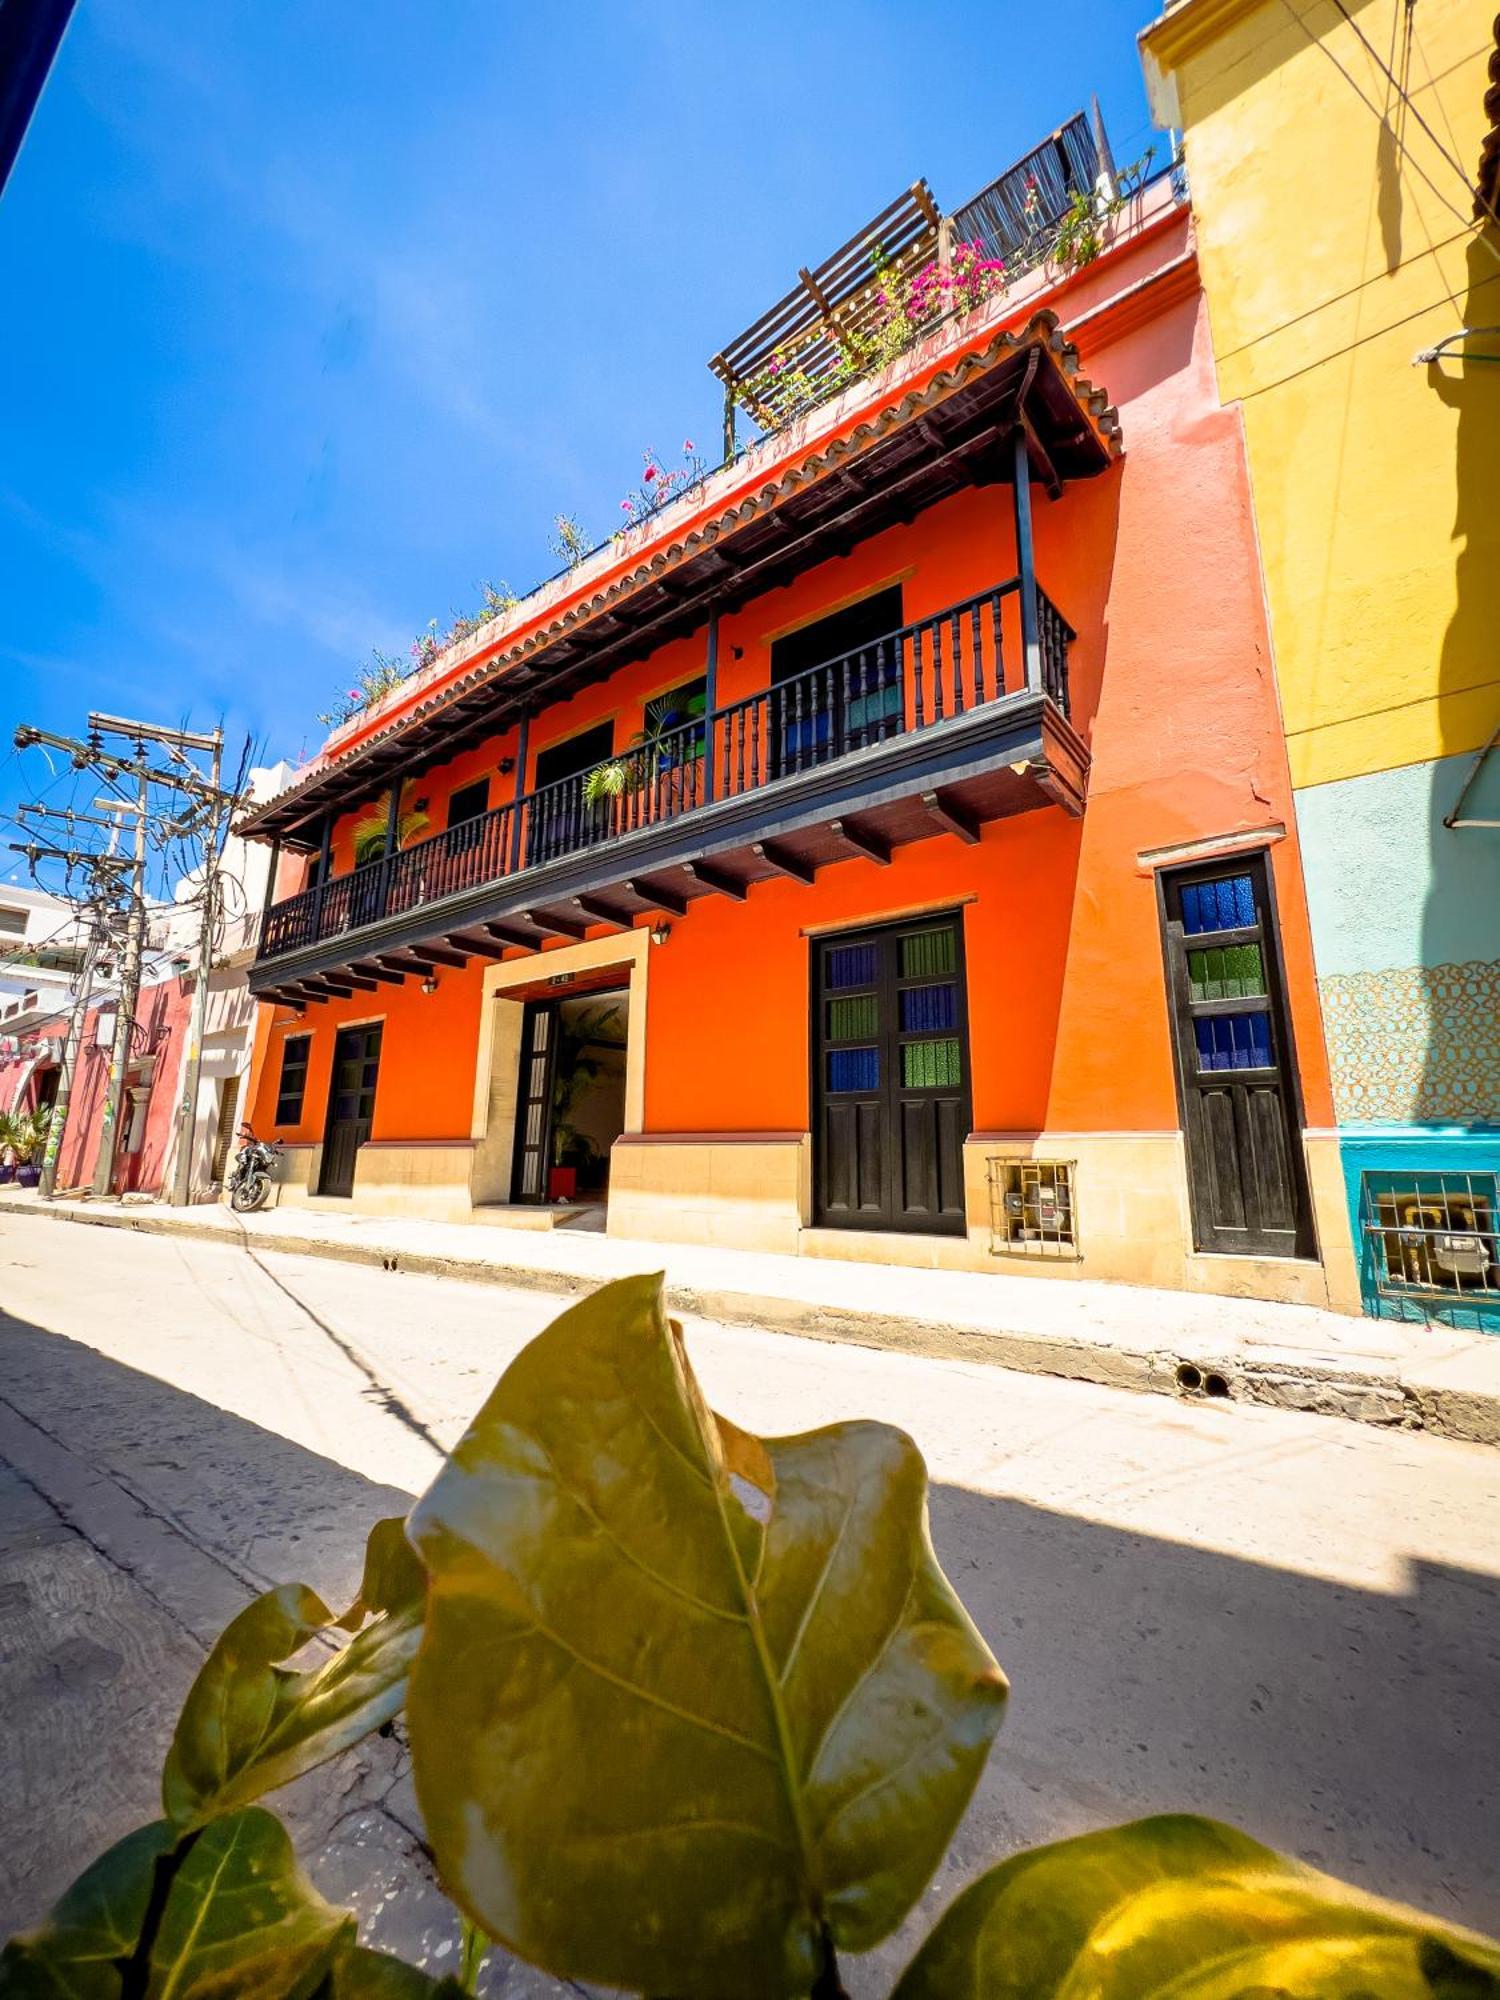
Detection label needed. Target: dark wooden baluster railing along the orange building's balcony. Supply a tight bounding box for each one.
[258,578,1074,960]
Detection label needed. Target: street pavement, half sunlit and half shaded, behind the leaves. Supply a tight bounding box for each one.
[0,1218,1500,2000]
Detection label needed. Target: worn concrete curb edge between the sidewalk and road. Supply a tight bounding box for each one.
[0,1198,1500,1446]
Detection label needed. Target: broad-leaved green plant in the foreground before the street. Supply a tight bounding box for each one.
[0,1278,1500,2000]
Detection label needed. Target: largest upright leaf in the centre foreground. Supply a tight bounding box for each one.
[408,1278,1006,2000]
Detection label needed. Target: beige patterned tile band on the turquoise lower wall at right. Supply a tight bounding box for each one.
[1320,960,1500,1124]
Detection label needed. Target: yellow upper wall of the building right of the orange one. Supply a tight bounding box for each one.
[1144,0,1500,786]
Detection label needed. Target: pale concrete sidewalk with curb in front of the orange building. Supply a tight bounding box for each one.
[0,1190,1500,1444]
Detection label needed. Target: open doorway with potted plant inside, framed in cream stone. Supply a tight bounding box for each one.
[512,988,630,1206]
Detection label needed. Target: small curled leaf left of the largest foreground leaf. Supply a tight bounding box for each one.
[162,1520,426,1828]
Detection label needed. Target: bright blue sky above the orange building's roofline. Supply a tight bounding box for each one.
[0,0,1150,876]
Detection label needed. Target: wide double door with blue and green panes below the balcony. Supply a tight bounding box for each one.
[812,916,970,1236]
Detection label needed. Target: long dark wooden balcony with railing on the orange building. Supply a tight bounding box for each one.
[250,578,1088,1006]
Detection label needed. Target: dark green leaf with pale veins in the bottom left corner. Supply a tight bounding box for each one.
[0,1808,352,2000]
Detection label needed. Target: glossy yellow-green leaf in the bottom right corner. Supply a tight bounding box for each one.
[894,1816,1500,2000]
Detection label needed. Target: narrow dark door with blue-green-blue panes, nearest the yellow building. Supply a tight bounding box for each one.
[1162,854,1312,1256]
